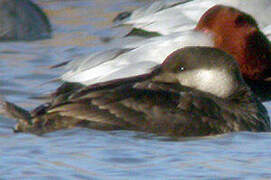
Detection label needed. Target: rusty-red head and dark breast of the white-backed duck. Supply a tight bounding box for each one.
[195,5,271,81]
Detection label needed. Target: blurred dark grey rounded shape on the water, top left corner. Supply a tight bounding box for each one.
[0,0,52,42]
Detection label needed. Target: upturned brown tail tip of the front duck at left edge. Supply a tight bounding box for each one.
[0,98,32,125]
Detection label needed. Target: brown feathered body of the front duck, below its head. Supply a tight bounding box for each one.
[11,77,268,136]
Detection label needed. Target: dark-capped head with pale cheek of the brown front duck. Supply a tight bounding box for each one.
[153,47,246,98]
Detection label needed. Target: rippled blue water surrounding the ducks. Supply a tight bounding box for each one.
[0,0,271,179]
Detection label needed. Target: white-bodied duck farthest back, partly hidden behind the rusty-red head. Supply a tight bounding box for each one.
[114,0,271,35]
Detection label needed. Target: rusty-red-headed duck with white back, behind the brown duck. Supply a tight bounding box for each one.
[60,5,271,101]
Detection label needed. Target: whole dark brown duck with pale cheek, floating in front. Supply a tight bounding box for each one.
[0,46,270,137]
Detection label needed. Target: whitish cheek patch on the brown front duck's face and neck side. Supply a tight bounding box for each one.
[177,69,234,98]
